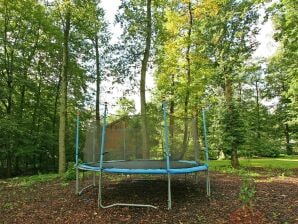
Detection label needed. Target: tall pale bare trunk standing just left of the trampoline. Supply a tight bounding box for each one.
[58,9,70,174]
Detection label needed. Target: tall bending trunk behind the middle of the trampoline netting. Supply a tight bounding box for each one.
[140,0,152,159]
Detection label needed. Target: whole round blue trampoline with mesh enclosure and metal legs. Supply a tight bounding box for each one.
[76,101,210,209]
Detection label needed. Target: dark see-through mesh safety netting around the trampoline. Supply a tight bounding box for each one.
[83,115,198,165]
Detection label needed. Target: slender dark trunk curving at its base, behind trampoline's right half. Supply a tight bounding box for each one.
[178,1,193,159]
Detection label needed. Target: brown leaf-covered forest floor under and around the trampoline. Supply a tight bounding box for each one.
[0,169,298,224]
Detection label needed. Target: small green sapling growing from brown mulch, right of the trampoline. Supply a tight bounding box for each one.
[239,175,256,206]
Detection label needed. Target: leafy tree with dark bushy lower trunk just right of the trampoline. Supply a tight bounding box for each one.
[203,0,258,167]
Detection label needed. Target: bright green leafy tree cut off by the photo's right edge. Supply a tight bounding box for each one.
[267,0,298,154]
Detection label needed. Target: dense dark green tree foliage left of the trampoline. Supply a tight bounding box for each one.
[0,0,108,177]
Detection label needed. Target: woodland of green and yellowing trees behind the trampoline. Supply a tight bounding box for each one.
[0,0,298,178]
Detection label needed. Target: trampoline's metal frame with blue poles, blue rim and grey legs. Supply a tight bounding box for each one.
[75,101,211,209]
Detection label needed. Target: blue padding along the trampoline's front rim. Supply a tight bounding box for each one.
[78,164,208,174]
